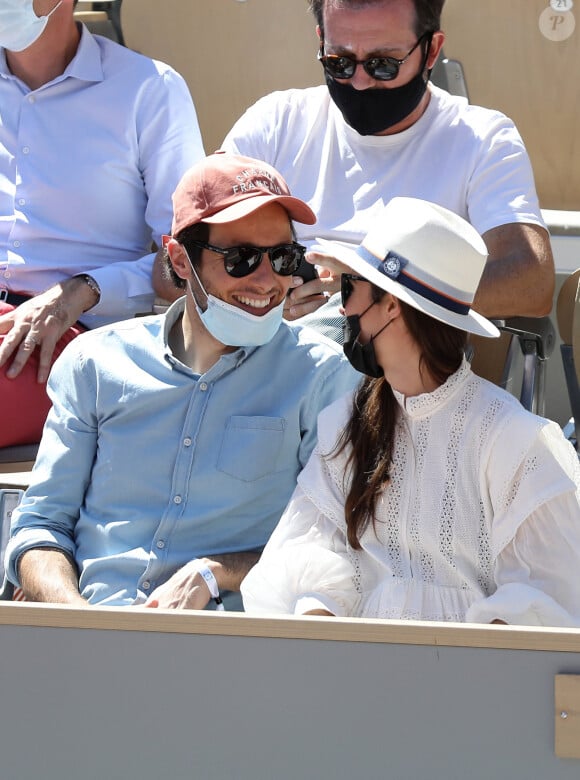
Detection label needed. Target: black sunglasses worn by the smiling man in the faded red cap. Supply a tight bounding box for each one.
[184,239,306,279]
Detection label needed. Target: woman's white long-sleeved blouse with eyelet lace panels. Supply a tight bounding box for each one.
[241,362,580,627]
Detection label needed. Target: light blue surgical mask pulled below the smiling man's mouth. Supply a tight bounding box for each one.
[190,266,284,347]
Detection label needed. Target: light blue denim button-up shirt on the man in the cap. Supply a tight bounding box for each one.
[6,298,360,605]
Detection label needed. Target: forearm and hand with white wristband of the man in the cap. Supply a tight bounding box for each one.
[145,551,260,609]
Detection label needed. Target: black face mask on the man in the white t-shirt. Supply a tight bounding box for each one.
[325,51,428,135]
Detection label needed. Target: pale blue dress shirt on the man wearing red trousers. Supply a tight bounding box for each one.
[0,27,204,328]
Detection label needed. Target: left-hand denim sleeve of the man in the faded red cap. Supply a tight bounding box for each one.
[6,341,97,584]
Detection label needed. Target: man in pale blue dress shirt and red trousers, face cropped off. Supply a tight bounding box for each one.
[0,0,204,446]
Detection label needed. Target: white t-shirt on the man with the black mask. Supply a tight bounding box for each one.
[223,85,544,245]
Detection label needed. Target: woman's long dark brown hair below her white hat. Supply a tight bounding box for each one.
[329,285,467,550]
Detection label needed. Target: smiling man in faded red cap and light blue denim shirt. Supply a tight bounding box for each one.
[6,153,357,609]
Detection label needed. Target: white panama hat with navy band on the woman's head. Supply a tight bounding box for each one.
[317,198,499,338]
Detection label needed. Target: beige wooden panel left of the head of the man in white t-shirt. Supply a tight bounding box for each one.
[122,0,322,153]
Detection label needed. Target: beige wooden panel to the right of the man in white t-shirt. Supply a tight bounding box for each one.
[444,0,580,210]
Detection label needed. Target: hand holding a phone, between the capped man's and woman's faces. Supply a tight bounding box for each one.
[284,252,351,320]
